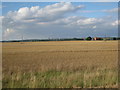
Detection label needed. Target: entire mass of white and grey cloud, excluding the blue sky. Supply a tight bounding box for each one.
[0,2,117,39]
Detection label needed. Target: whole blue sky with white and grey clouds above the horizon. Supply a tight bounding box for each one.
[0,2,118,40]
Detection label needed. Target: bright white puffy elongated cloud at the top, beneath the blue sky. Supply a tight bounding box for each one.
[7,2,84,21]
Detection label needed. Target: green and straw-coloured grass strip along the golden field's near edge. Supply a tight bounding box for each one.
[3,70,118,88]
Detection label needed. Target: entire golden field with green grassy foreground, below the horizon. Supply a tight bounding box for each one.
[2,41,118,88]
